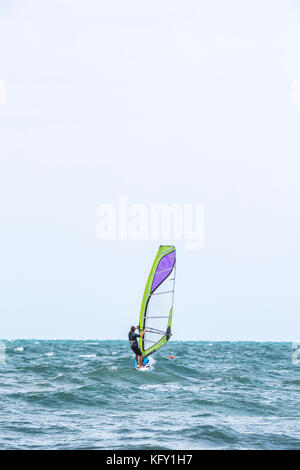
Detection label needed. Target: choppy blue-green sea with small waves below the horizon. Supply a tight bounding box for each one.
[0,340,300,450]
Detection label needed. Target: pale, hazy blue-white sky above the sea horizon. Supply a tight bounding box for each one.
[0,0,300,341]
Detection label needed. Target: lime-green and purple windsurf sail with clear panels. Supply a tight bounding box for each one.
[139,245,176,357]
